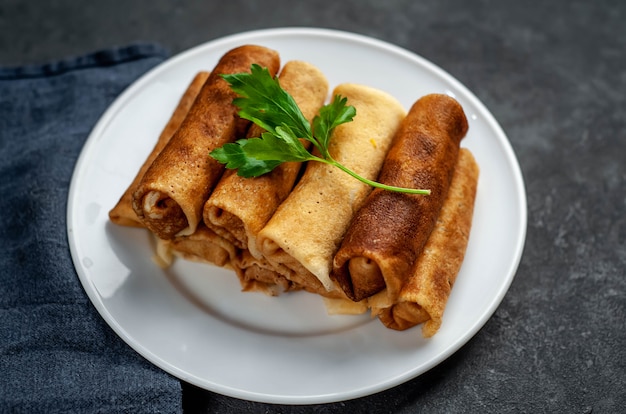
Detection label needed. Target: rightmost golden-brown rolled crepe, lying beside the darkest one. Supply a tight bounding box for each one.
[372,149,479,337]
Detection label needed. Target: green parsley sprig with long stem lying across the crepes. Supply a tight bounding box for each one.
[210,64,430,194]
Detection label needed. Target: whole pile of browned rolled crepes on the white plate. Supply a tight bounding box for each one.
[110,46,478,336]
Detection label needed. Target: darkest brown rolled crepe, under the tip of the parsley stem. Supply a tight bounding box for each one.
[332,94,468,302]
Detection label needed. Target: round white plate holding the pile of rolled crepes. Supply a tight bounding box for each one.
[67,28,526,404]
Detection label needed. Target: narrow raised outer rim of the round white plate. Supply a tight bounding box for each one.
[66,27,527,405]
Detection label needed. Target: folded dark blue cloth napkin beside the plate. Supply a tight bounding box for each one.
[0,45,182,413]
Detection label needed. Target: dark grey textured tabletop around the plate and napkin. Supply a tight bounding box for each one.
[0,0,626,413]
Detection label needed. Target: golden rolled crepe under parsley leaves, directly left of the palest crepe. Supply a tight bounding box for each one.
[203,61,328,258]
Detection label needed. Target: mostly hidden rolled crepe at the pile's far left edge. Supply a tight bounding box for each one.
[109,72,209,227]
